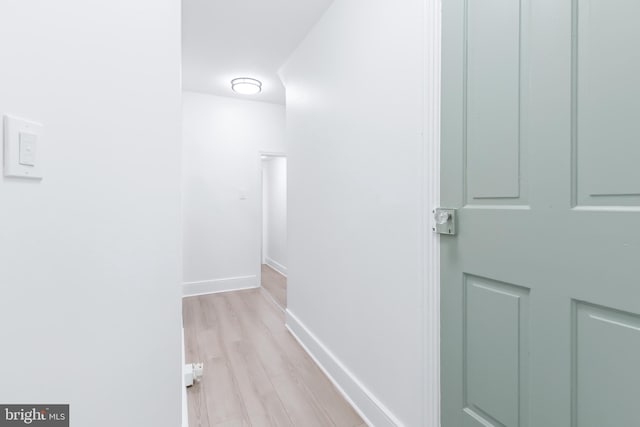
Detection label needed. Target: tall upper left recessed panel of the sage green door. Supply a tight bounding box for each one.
[464,0,521,203]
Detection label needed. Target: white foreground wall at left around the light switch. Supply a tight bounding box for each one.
[0,0,181,427]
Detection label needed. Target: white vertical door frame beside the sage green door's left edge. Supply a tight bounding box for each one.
[422,0,442,427]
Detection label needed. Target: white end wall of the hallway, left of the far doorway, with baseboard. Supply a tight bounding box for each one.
[183,92,285,293]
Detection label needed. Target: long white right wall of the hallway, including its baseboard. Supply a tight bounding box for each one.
[282,0,426,426]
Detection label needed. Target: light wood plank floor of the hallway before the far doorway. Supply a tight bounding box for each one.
[183,289,365,427]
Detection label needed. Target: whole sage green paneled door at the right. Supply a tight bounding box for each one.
[441,0,640,427]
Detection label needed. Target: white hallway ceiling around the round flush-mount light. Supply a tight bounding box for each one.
[182,0,333,104]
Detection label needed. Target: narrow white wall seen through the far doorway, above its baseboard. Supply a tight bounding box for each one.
[262,157,287,274]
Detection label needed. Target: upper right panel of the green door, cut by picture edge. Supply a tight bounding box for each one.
[573,0,640,206]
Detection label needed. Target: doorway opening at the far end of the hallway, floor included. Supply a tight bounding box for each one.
[260,153,287,310]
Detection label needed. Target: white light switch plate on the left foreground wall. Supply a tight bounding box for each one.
[4,116,42,179]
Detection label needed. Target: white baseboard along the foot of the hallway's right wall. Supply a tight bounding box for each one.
[286,309,403,427]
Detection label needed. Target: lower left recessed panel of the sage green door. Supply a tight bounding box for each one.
[463,276,529,426]
